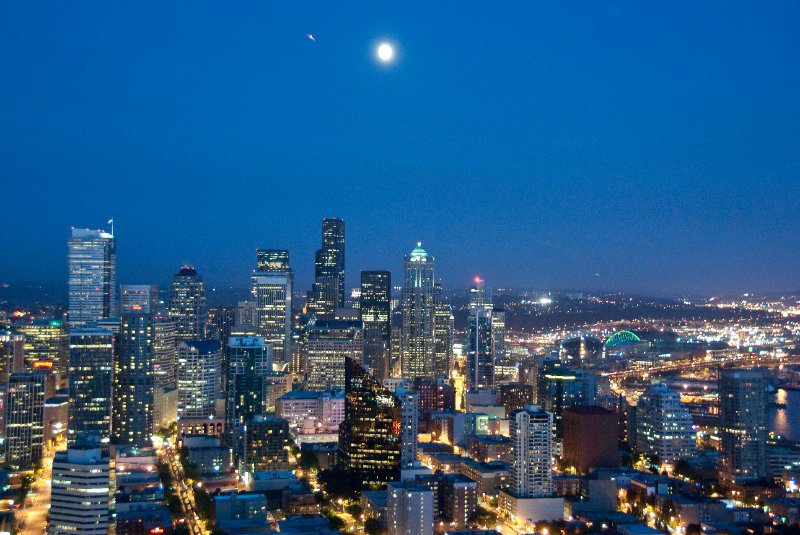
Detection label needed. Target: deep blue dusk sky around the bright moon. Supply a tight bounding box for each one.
[0,2,800,294]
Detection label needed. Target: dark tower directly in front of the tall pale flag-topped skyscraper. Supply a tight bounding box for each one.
[67,327,114,444]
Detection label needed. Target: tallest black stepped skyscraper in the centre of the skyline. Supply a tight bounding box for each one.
[308,218,345,320]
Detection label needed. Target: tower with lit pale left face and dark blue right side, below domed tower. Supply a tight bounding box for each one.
[178,340,222,418]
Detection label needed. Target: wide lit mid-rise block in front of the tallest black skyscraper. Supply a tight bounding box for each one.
[303,319,364,391]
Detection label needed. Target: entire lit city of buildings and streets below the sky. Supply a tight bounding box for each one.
[0,219,800,535]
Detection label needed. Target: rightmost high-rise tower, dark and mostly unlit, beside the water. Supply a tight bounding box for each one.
[719,369,767,483]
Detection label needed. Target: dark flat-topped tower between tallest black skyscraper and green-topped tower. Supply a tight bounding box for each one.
[359,271,392,381]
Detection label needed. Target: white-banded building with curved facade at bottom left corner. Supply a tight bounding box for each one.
[48,435,113,535]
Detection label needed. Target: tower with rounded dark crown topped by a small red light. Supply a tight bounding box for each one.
[169,266,207,341]
